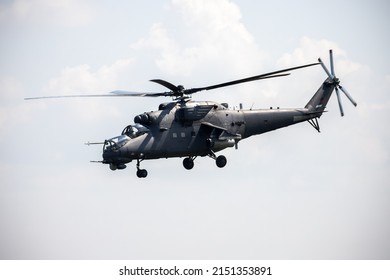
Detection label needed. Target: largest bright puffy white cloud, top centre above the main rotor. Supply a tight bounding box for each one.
[132,0,264,79]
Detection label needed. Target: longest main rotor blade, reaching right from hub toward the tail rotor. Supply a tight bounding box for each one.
[186,63,319,94]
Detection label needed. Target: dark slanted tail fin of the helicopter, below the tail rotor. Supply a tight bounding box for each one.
[305,78,335,117]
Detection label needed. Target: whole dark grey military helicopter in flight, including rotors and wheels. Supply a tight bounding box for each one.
[26,50,357,178]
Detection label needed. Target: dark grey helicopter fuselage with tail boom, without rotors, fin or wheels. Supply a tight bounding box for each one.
[103,100,322,169]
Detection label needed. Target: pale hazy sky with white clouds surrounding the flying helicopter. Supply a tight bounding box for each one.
[0,0,390,259]
